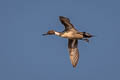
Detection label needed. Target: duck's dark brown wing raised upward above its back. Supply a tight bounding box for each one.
[59,16,75,31]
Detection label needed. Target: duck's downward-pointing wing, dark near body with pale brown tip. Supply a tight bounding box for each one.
[68,39,79,67]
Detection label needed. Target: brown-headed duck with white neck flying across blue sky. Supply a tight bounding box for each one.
[43,16,93,68]
